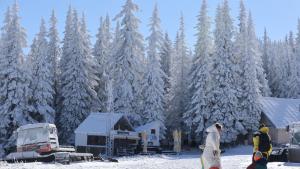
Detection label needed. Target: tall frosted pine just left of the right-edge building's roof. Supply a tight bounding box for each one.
[236,10,265,134]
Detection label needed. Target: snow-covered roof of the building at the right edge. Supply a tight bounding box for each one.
[260,97,300,128]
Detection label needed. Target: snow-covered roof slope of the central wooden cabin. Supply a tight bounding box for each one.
[75,113,124,135]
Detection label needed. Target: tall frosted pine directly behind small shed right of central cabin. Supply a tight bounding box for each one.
[142,5,166,138]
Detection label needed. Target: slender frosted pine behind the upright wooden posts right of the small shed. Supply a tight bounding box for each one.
[167,14,191,129]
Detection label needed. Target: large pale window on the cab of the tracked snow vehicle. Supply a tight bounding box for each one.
[17,127,49,147]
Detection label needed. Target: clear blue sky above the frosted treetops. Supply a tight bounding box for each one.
[0,0,300,52]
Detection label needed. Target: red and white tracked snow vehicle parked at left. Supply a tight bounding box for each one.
[5,123,93,163]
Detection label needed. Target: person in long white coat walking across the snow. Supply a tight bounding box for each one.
[201,123,223,169]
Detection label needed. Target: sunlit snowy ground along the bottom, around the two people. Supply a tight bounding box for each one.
[0,147,300,169]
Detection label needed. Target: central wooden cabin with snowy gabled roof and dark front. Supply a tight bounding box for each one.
[75,113,140,156]
